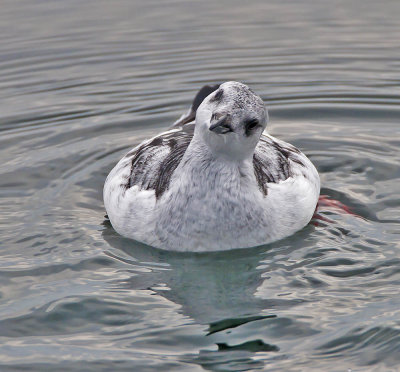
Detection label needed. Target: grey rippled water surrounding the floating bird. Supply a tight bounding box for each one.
[0,0,400,371]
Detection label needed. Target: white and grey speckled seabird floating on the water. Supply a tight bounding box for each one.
[104,82,319,251]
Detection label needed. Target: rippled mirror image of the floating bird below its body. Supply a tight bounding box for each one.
[102,221,282,364]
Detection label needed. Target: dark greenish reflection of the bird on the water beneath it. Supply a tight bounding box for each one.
[102,220,293,366]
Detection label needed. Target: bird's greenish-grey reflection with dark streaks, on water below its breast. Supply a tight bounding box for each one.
[97,220,328,370]
